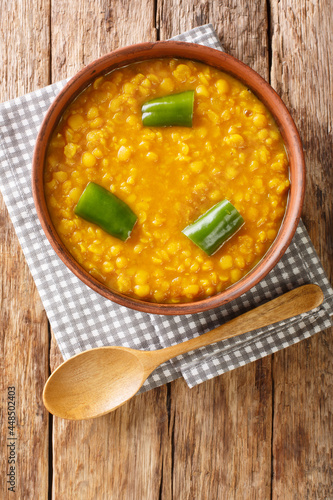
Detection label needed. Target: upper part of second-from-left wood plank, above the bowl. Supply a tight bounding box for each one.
[51,0,156,82]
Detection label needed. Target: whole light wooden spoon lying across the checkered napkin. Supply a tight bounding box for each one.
[43,285,324,420]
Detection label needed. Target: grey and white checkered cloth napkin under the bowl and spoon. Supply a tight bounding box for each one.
[0,25,333,390]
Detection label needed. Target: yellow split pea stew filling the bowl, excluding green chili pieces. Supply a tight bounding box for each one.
[44,59,290,303]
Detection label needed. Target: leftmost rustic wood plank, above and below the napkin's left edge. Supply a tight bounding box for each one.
[0,0,50,500]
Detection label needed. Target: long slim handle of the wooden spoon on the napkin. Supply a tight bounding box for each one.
[153,285,324,366]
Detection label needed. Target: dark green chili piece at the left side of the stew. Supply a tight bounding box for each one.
[74,182,137,241]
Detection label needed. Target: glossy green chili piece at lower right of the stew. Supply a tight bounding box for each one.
[182,200,244,255]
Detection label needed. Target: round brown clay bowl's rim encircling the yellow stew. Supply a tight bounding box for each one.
[32,41,305,315]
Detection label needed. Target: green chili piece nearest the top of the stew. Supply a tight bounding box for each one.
[141,90,194,127]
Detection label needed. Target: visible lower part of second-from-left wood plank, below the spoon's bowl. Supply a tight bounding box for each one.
[53,328,171,500]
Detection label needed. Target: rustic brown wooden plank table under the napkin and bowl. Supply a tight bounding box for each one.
[0,0,333,500]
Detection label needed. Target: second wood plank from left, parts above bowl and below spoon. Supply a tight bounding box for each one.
[51,0,171,500]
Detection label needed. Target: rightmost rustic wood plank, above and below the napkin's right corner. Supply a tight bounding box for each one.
[271,0,333,499]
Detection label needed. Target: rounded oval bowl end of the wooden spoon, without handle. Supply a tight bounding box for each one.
[43,347,146,419]
